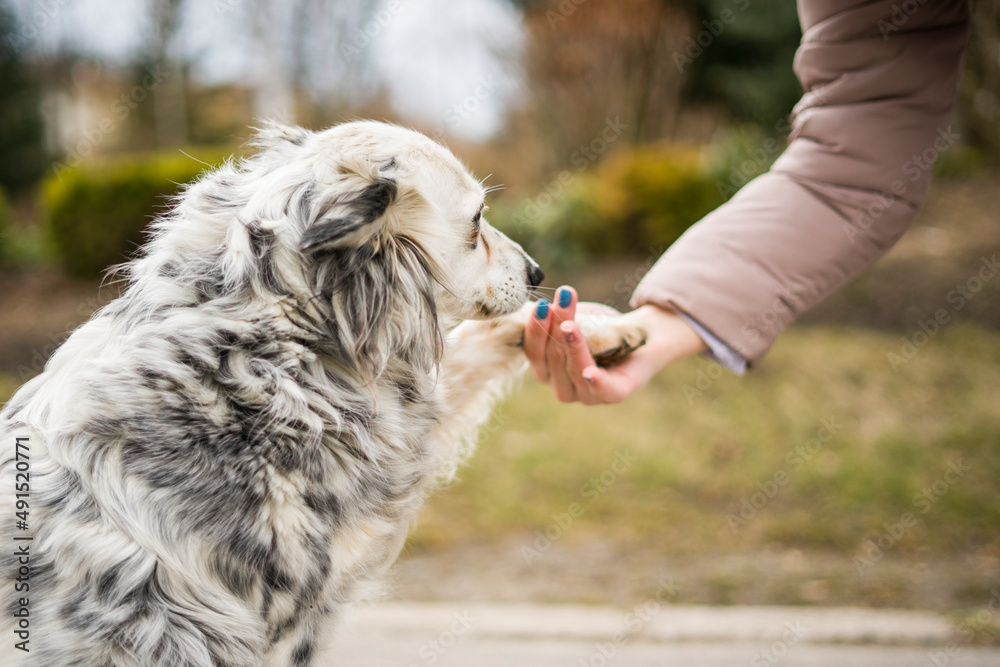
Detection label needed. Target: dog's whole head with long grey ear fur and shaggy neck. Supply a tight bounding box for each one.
[133,121,542,376]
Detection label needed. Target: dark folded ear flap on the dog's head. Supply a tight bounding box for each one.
[300,176,398,253]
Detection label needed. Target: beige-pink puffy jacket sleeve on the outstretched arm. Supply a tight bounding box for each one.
[632,0,971,365]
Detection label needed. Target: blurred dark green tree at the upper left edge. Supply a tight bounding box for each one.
[0,5,47,192]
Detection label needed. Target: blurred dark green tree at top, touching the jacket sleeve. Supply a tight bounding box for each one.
[682,0,802,133]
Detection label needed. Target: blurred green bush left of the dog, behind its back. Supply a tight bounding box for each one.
[42,151,230,276]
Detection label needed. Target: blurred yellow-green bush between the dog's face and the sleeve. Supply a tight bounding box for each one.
[504,144,723,267]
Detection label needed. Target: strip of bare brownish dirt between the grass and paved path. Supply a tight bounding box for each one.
[390,534,1000,611]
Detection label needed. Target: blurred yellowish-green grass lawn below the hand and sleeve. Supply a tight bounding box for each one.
[410,320,1000,557]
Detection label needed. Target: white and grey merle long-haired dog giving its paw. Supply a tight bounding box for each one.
[0,121,644,667]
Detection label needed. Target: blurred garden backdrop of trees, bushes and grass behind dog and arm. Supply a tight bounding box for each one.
[0,0,1000,641]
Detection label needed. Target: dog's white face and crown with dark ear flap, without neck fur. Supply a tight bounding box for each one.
[286,121,543,320]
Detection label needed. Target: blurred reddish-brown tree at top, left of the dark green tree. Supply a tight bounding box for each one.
[517,0,690,175]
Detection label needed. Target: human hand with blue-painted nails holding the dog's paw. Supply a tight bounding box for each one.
[524,287,705,405]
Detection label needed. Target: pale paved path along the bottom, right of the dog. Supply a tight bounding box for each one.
[317,602,1000,667]
